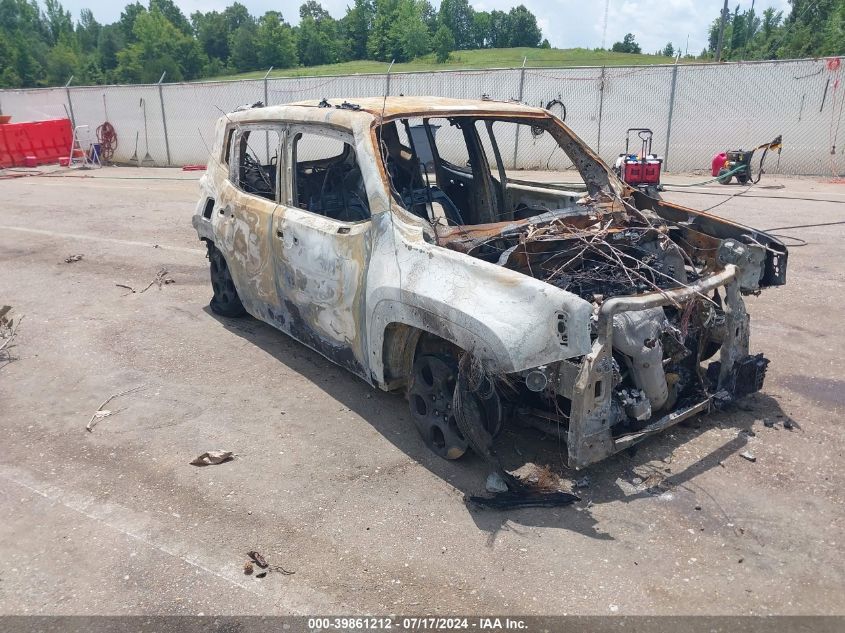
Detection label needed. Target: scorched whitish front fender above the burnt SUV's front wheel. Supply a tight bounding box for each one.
[367,214,592,381]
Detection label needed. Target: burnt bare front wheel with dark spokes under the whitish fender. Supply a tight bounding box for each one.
[408,354,469,459]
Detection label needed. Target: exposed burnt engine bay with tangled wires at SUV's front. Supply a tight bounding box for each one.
[436,188,786,465]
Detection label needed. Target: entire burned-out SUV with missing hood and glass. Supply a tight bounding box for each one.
[193,97,787,468]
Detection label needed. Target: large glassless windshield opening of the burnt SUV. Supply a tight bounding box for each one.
[379,116,600,226]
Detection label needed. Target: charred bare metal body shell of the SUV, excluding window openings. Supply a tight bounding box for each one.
[193,97,787,468]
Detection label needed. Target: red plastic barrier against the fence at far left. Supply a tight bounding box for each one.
[0,119,73,167]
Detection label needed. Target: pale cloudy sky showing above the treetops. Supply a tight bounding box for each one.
[51,0,789,55]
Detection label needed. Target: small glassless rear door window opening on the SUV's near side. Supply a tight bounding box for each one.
[236,129,281,201]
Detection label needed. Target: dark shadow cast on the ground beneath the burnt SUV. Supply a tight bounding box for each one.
[205,307,800,546]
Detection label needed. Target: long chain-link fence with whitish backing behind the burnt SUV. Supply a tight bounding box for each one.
[0,59,845,176]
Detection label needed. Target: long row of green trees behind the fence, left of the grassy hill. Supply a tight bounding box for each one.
[0,0,549,87]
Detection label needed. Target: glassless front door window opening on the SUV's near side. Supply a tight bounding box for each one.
[292,132,370,222]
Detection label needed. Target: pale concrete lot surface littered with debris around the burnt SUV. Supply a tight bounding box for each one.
[0,168,845,615]
